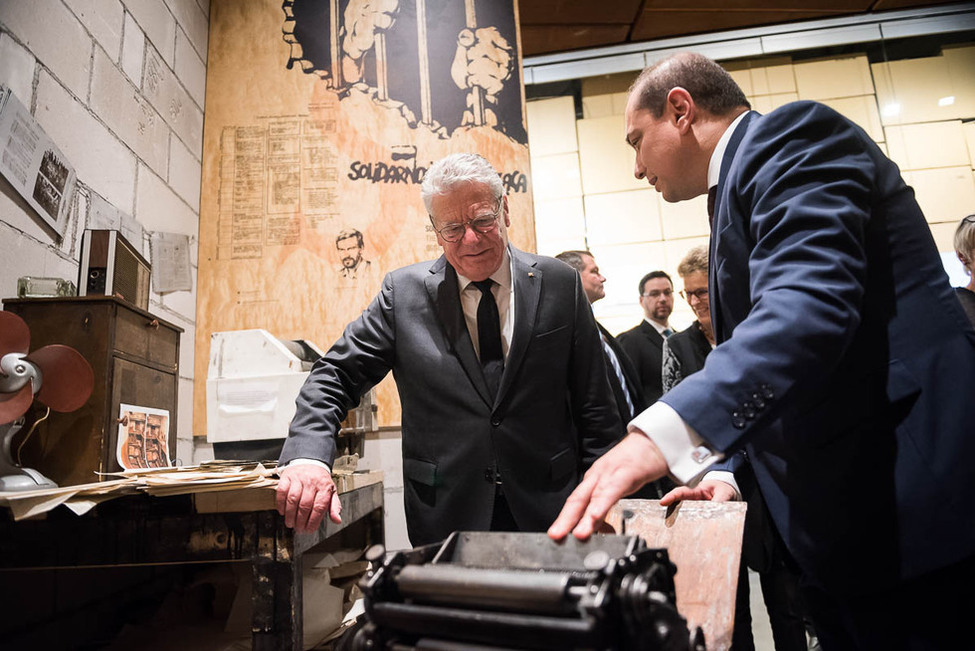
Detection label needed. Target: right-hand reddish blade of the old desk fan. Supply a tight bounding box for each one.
[24,344,95,411]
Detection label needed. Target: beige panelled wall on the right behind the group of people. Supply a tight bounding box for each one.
[527,44,975,333]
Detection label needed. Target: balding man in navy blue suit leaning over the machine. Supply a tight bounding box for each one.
[549,53,975,649]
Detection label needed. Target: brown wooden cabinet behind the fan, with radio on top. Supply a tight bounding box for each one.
[3,296,183,486]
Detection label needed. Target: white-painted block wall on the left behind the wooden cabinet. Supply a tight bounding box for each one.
[0,0,210,464]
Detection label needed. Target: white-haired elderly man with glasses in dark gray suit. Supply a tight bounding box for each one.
[277,154,623,545]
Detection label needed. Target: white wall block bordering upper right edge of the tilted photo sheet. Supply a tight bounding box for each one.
[34,72,136,214]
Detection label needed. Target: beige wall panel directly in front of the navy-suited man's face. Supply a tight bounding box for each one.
[576,115,647,194]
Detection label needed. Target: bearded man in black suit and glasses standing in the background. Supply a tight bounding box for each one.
[618,271,674,404]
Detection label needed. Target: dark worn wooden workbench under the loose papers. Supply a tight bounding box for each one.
[0,482,384,651]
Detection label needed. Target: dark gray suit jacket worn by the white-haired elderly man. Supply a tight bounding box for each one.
[280,247,623,545]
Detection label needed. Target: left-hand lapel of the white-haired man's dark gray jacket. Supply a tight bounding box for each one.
[423,256,494,405]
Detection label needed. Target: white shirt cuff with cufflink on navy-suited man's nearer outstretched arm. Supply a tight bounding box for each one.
[627,400,724,486]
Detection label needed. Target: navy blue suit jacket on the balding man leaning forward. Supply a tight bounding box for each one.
[663,102,975,593]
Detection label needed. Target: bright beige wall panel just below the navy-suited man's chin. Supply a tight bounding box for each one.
[588,188,663,246]
